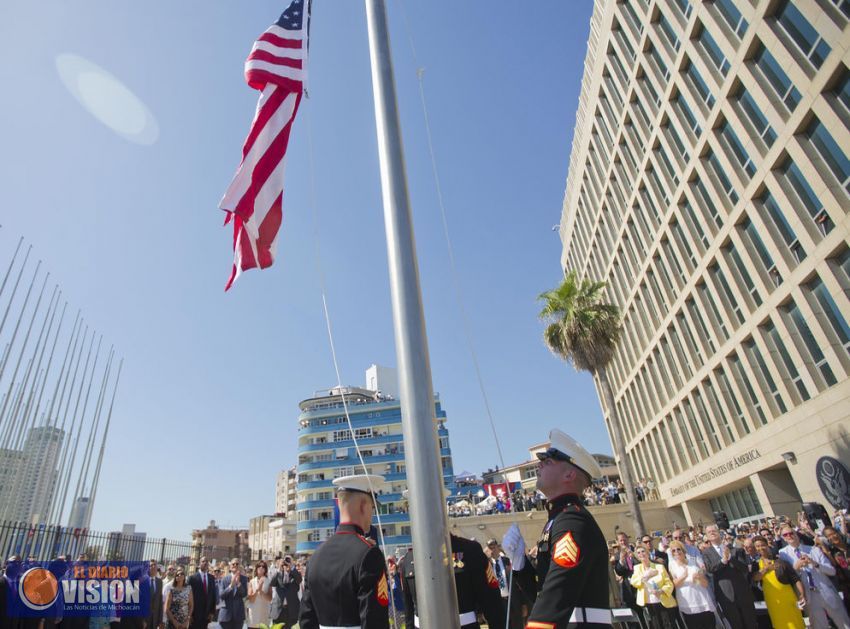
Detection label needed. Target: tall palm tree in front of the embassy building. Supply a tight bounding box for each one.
[538,271,644,538]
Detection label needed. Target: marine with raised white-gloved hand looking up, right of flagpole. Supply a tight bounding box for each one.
[502,430,611,629]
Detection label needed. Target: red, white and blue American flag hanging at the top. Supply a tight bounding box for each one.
[219,0,310,290]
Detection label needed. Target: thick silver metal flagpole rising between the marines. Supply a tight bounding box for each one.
[366,0,460,629]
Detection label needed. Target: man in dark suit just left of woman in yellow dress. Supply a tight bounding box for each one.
[702,524,758,629]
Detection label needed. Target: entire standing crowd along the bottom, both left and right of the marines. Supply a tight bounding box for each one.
[3,506,850,629]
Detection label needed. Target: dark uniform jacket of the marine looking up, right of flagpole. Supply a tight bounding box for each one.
[523,494,611,629]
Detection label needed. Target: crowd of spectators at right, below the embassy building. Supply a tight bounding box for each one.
[609,510,850,629]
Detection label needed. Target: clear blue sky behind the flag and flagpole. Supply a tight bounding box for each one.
[0,0,596,539]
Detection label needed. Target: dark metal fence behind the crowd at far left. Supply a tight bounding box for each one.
[0,521,235,566]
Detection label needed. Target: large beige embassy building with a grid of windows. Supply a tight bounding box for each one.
[560,0,850,524]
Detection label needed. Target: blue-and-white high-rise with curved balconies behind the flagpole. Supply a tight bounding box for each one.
[297,365,454,553]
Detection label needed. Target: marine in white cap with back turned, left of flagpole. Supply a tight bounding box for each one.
[298,474,390,629]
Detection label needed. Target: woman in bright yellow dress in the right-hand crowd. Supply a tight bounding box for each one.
[753,535,806,629]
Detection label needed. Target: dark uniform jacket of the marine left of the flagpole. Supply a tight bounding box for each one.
[298,524,390,629]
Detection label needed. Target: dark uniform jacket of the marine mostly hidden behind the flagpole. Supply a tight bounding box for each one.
[398,535,505,629]
